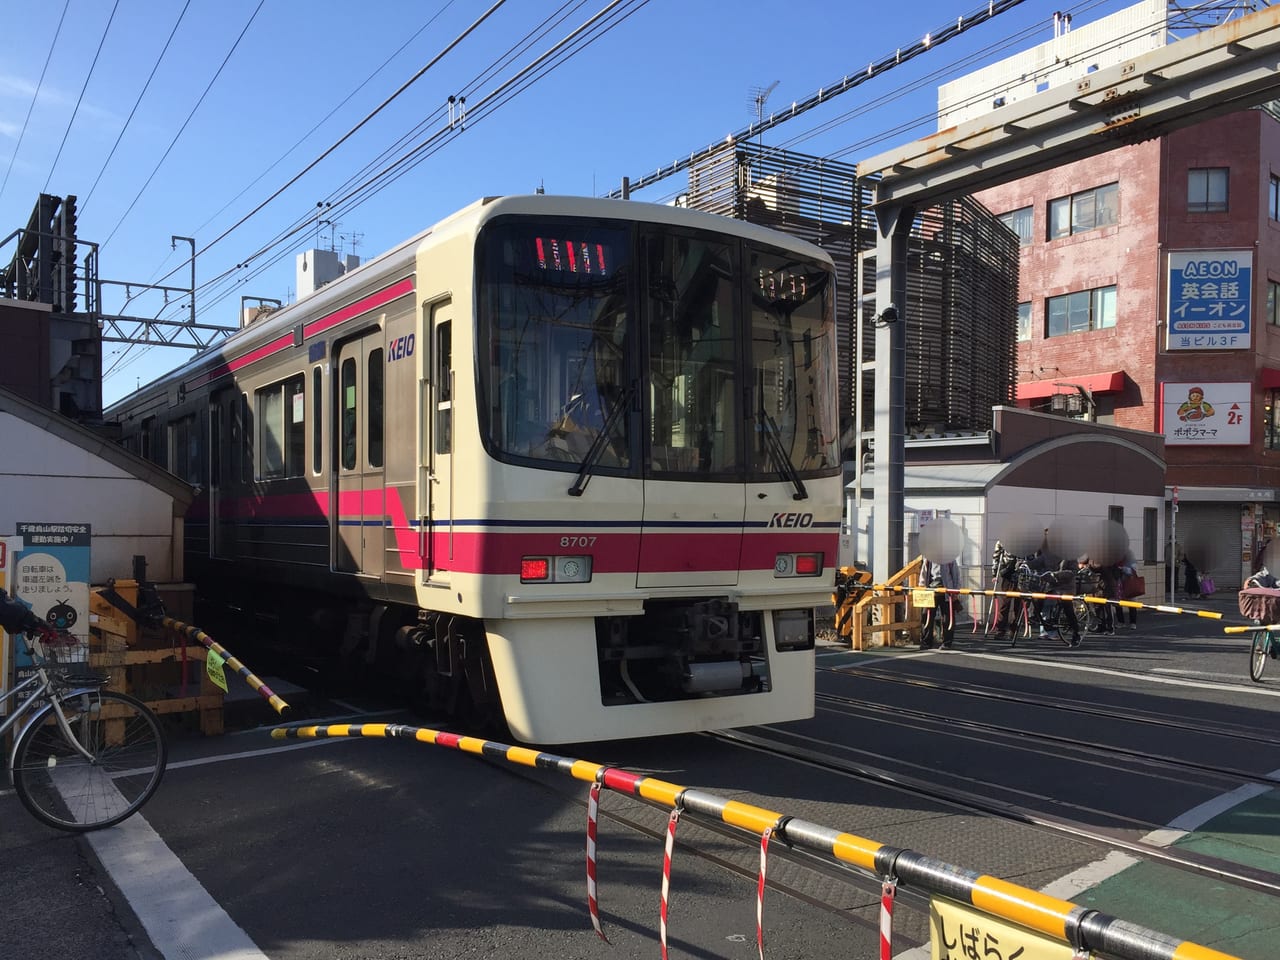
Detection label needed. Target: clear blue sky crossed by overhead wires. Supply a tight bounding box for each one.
[0,0,1129,403]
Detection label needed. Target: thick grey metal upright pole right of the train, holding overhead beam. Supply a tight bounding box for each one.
[872,205,915,580]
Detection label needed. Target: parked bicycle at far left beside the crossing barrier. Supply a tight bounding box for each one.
[0,627,169,832]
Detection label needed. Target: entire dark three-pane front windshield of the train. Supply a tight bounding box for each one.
[476,218,840,481]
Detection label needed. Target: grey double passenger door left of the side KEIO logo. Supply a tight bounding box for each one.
[332,330,387,576]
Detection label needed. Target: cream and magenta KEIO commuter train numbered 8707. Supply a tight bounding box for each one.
[105,193,844,744]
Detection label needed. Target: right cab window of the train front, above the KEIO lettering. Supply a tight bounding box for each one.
[748,251,840,476]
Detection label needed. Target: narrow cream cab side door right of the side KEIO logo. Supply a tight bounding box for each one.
[422,300,453,585]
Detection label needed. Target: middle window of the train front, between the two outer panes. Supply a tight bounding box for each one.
[645,234,741,474]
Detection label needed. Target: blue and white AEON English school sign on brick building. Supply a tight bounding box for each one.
[1166,250,1253,349]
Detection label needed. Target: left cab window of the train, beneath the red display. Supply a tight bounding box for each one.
[476,218,635,471]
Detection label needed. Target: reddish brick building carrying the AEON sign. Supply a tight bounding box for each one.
[977,4,1280,593]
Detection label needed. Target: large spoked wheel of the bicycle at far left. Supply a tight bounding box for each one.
[13,690,168,832]
